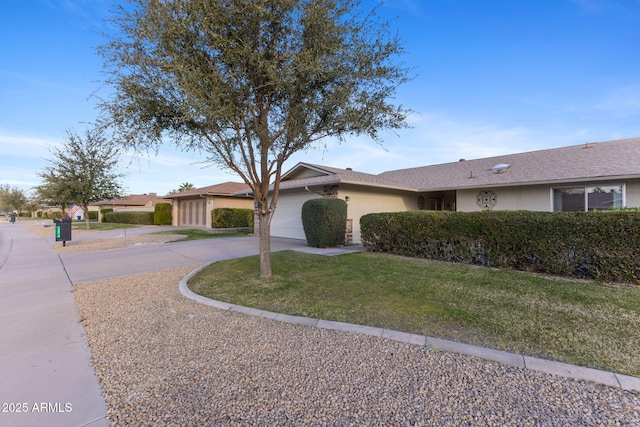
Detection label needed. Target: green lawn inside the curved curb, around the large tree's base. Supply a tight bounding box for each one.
[189,251,640,376]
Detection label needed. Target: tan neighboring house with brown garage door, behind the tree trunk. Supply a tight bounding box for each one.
[165,182,253,228]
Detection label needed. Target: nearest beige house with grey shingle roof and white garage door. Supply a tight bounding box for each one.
[271,138,640,243]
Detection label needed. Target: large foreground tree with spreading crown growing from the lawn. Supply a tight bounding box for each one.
[98,0,409,277]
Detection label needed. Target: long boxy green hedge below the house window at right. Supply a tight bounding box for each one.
[360,211,640,283]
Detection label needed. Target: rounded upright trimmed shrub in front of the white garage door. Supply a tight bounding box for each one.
[302,198,347,248]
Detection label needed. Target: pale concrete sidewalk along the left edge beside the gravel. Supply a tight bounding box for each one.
[0,222,109,427]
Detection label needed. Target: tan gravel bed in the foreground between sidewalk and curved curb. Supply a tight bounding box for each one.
[74,267,640,426]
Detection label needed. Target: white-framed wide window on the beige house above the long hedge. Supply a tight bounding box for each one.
[553,185,624,212]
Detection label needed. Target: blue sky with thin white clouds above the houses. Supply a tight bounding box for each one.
[0,0,640,194]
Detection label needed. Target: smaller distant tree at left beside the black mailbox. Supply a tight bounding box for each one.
[36,128,124,230]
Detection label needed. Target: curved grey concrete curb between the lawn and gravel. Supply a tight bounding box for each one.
[178,265,640,391]
